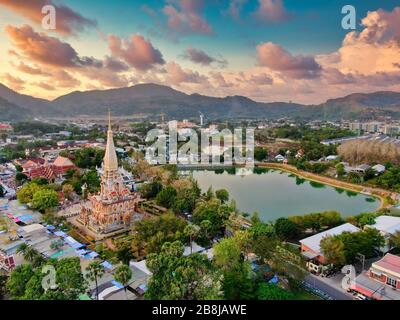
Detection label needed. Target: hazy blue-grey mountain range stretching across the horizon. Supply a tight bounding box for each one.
[0,84,400,121]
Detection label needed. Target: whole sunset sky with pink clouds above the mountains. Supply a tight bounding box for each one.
[0,0,400,104]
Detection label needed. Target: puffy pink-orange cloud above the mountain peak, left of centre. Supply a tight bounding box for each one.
[108,34,165,71]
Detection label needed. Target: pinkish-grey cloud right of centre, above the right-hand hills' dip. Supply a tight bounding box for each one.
[257,42,321,79]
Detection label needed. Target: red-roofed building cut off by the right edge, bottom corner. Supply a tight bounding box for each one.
[351,253,400,300]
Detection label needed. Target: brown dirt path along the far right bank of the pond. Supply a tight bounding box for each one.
[257,162,392,210]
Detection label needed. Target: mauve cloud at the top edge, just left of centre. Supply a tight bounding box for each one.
[163,0,212,34]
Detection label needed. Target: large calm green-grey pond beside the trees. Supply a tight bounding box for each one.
[185,168,380,221]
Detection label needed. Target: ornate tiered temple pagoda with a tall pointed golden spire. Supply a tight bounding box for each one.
[77,117,140,237]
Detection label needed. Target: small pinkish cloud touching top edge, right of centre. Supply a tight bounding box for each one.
[254,0,292,23]
